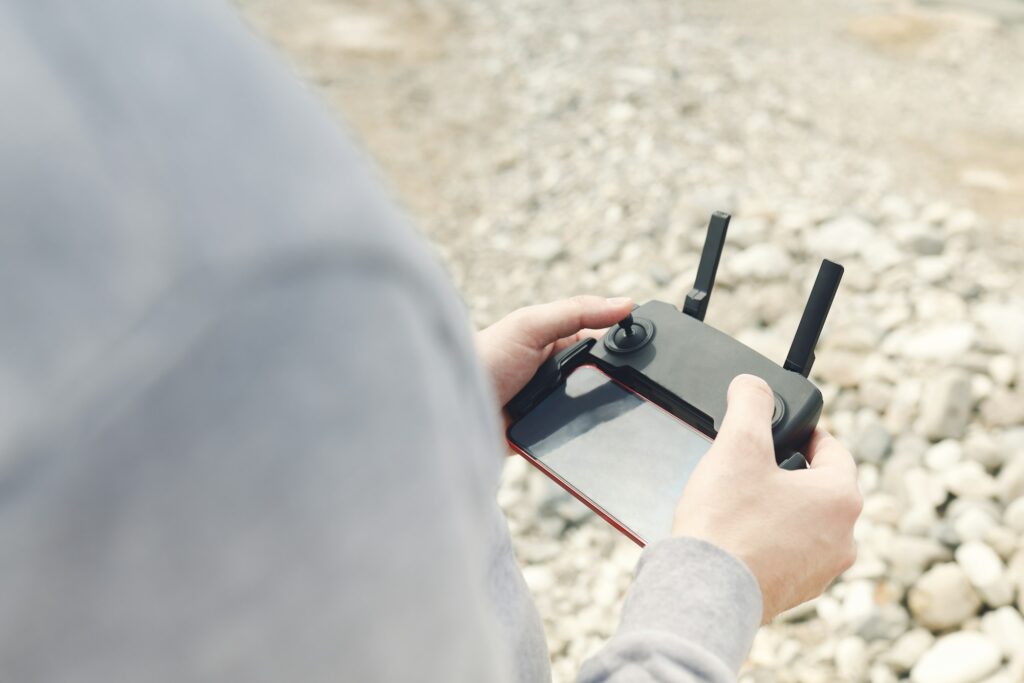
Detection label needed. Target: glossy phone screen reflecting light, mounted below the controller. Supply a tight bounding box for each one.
[508,366,712,543]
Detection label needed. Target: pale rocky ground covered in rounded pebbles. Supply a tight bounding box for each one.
[240,0,1024,683]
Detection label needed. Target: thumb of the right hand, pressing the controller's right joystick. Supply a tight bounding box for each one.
[715,375,775,462]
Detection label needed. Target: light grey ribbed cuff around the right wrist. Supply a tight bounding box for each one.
[620,538,763,672]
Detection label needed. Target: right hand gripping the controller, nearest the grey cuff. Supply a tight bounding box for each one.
[673,375,862,623]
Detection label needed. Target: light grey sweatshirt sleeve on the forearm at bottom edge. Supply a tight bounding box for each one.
[580,538,762,683]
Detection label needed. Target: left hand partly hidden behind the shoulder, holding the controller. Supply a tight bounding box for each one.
[476,296,633,405]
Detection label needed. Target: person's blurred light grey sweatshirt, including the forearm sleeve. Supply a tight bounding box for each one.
[0,0,761,683]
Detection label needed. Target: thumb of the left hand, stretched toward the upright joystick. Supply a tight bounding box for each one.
[515,296,633,349]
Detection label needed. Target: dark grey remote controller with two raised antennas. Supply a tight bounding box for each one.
[506,213,843,469]
